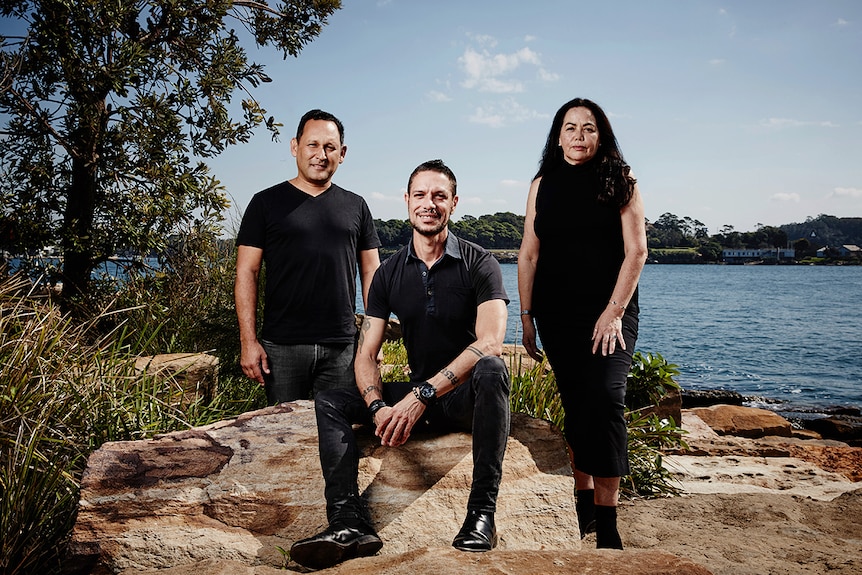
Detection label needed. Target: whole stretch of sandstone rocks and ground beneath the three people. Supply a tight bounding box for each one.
[67,402,862,575]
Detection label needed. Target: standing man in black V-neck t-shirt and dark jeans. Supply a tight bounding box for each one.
[234,110,380,404]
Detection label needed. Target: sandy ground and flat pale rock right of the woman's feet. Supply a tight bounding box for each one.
[608,417,862,575]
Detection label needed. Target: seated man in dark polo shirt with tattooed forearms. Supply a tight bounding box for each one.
[290,160,510,569]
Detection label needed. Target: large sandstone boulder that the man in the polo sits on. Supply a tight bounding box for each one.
[69,401,580,574]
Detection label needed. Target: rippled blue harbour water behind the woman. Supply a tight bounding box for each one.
[502,264,862,413]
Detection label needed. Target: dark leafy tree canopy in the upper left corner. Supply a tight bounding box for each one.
[0,0,341,308]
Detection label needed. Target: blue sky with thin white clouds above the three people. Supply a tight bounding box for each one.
[6,0,862,233]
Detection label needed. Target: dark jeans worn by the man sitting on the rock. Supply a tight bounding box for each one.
[314,357,511,525]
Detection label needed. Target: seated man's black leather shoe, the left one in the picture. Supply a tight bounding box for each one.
[290,523,383,569]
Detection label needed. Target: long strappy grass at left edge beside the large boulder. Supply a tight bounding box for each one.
[0,268,265,575]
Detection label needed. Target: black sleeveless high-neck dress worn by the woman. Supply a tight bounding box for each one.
[532,161,639,477]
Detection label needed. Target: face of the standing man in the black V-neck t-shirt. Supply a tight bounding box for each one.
[290,120,347,185]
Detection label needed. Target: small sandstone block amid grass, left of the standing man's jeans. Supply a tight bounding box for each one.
[135,353,218,405]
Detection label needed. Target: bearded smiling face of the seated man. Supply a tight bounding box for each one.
[404,170,458,236]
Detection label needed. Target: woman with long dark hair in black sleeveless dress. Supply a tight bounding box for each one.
[518,98,647,549]
